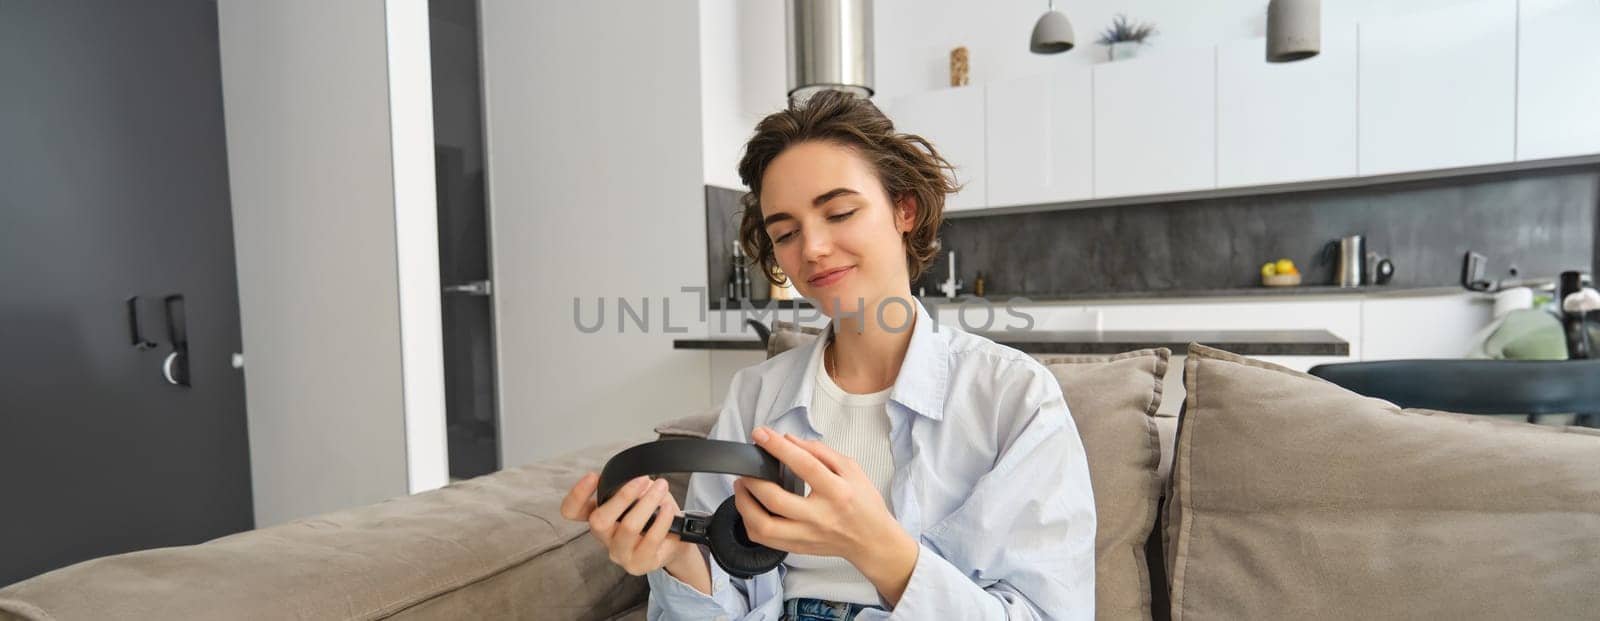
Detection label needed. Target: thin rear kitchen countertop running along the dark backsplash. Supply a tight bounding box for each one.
[709,285,1467,311]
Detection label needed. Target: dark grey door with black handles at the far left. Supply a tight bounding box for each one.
[0,0,253,584]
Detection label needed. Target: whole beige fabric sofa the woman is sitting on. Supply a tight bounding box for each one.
[0,346,1600,619]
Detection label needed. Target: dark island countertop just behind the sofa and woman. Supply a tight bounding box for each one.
[672,330,1350,355]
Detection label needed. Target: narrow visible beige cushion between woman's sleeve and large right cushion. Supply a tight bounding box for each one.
[1038,349,1170,619]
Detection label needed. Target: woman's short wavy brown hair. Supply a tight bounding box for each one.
[739,91,960,286]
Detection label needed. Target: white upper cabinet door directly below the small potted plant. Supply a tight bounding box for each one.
[1093,48,1216,197]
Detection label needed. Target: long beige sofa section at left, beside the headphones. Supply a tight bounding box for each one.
[0,439,648,619]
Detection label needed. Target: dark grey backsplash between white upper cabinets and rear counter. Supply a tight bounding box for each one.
[706,166,1600,299]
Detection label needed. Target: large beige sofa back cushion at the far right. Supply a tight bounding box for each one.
[1166,346,1600,619]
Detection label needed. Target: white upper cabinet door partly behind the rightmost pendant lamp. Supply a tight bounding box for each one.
[1216,26,1358,187]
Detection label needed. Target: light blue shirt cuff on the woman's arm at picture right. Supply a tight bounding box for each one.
[888,543,1005,619]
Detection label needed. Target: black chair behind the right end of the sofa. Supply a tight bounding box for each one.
[1310,359,1600,426]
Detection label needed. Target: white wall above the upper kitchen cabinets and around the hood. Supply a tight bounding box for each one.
[701,0,1470,187]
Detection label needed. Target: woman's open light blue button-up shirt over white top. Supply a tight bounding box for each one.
[646,301,1094,621]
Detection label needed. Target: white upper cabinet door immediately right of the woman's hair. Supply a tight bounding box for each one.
[886,85,989,211]
